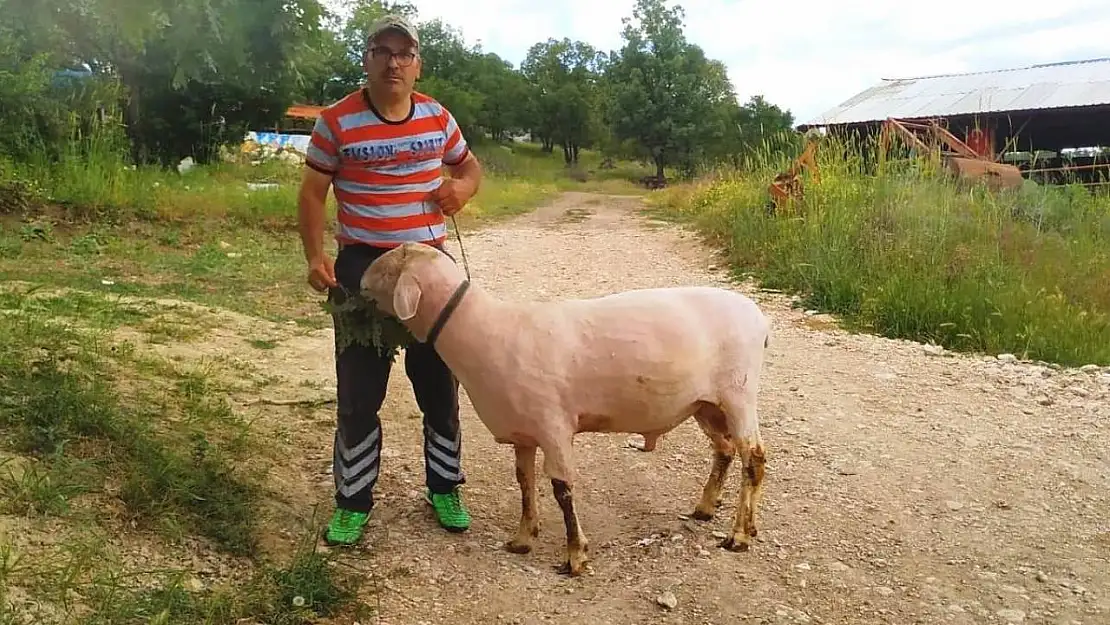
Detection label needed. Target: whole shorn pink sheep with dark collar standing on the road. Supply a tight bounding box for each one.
[361,243,770,575]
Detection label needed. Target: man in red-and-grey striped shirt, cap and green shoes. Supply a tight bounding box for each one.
[299,16,482,545]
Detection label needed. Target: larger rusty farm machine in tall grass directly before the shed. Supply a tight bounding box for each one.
[880,118,1025,191]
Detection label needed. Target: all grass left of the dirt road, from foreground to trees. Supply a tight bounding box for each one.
[0,128,643,625]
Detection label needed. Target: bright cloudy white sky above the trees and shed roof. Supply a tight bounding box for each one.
[327,0,1110,123]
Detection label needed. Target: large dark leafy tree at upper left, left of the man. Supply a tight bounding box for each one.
[6,0,323,164]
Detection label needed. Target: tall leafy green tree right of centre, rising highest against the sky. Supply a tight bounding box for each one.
[608,0,736,179]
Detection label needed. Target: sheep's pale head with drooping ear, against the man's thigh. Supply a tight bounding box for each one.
[360,243,457,322]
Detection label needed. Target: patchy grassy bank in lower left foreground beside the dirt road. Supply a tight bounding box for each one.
[0,276,375,625]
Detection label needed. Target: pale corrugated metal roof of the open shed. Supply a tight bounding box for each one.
[801,58,1110,128]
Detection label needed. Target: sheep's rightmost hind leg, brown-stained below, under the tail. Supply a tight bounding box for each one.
[720,392,766,552]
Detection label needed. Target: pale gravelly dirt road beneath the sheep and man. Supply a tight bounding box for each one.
[240,194,1110,625]
